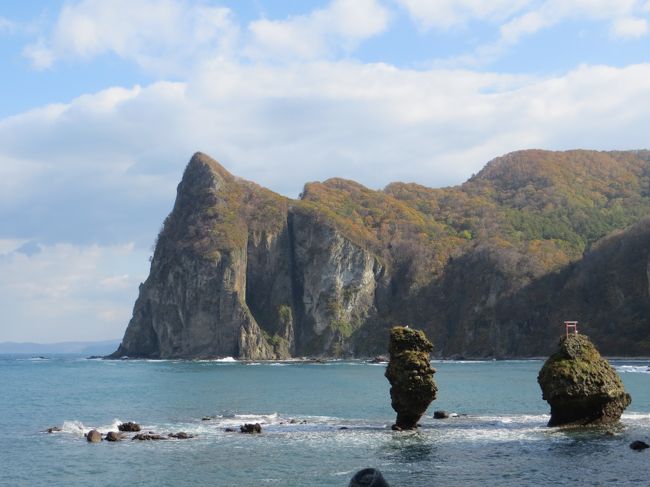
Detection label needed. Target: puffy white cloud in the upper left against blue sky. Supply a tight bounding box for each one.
[24,0,238,74]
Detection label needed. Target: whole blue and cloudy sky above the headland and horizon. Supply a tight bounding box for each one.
[0,0,650,343]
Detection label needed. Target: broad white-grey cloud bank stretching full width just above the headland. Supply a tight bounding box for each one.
[0,62,650,227]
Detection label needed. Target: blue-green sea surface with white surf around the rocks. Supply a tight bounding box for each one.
[0,355,650,487]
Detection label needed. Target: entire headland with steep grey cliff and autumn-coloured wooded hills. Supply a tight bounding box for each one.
[114,150,650,359]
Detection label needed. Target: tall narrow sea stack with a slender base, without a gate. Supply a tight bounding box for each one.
[385,326,438,430]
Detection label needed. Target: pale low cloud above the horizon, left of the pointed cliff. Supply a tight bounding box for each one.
[0,244,148,342]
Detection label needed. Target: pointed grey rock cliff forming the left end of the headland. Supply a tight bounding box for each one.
[111,154,383,359]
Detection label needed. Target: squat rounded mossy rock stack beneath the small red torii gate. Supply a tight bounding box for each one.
[537,333,632,426]
